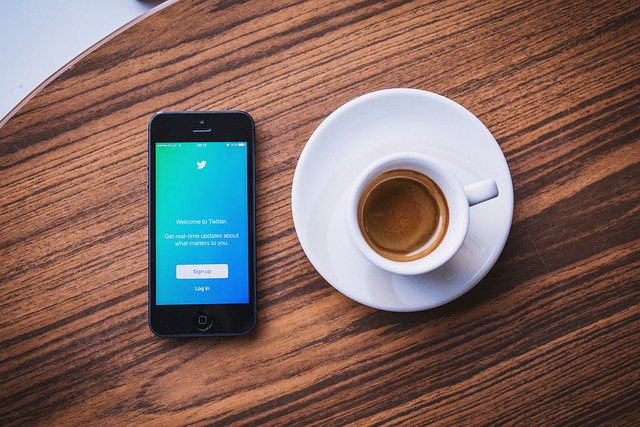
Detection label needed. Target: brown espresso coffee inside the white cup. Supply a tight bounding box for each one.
[358,169,449,261]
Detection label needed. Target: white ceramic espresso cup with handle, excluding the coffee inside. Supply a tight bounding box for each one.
[346,152,498,275]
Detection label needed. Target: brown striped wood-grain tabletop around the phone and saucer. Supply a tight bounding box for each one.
[0,0,640,426]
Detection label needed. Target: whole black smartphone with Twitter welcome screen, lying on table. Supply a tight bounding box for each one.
[149,111,256,337]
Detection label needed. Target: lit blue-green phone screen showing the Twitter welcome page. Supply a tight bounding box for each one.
[154,141,249,305]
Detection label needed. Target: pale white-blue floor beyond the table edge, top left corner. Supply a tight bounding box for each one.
[0,0,162,119]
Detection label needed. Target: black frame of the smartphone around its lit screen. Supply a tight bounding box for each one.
[148,110,257,337]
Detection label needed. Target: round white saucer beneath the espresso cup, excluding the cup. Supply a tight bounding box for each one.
[291,89,513,311]
